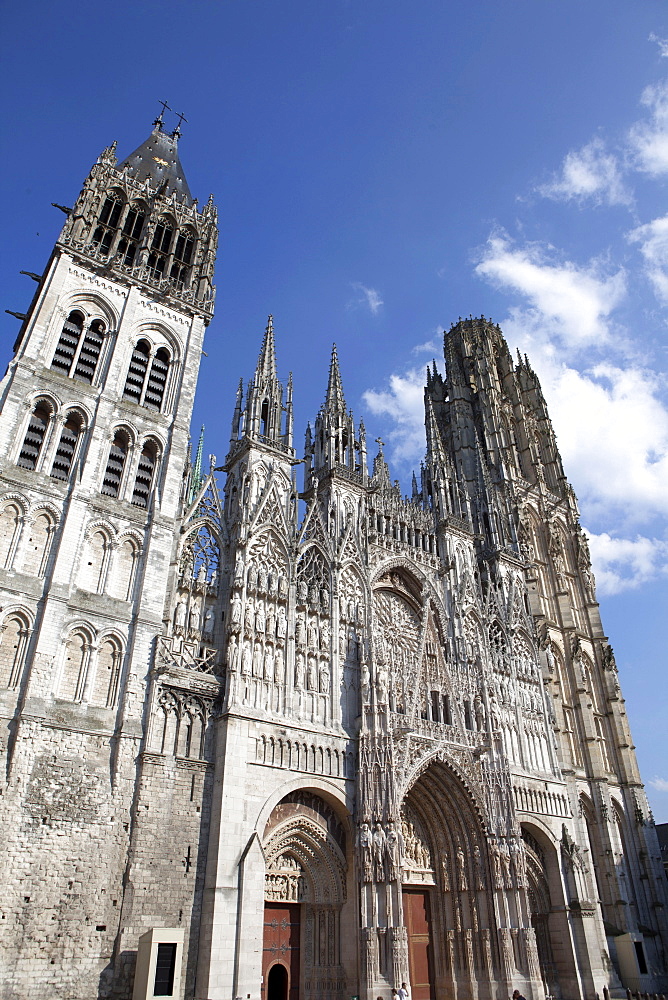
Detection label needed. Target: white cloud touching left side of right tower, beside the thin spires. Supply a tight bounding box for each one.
[362,368,426,463]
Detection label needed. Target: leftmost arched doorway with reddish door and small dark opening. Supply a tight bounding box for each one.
[262,789,347,1000]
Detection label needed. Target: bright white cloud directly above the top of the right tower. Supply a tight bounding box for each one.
[476,234,626,347]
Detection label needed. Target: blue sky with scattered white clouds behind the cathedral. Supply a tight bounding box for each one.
[0,0,668,821]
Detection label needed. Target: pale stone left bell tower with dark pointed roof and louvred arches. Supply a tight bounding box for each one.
[0,116,217,996]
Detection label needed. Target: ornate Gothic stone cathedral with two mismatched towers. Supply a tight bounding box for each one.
[0,118,667,1000]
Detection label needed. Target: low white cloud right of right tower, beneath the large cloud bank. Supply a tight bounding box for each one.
[589,532,668,595]
